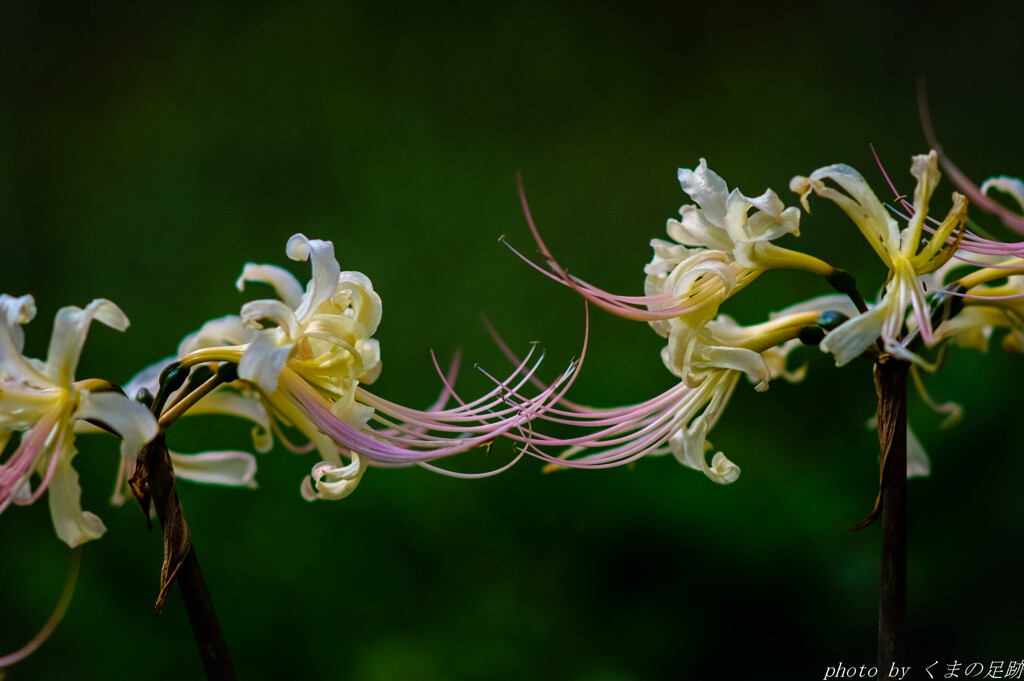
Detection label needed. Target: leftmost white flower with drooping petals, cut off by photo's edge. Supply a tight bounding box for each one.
[0,294,157,547]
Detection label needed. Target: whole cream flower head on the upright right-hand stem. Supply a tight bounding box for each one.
[510,152,1024,483]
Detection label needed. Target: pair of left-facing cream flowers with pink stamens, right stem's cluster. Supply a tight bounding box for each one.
[503,159,846,484]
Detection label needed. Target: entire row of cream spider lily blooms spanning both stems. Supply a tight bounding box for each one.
[8,152,1024,546]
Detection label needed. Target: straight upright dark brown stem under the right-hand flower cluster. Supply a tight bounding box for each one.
[874,355,909,679]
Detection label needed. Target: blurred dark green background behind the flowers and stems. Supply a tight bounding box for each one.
[0,1,1024,681]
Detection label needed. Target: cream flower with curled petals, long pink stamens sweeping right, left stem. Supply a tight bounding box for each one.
[168,235,575,500]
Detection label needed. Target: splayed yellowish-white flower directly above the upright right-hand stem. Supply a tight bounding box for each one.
[790,151,967,367]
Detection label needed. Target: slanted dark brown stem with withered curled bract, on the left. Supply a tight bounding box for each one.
[139,433,237,680]
